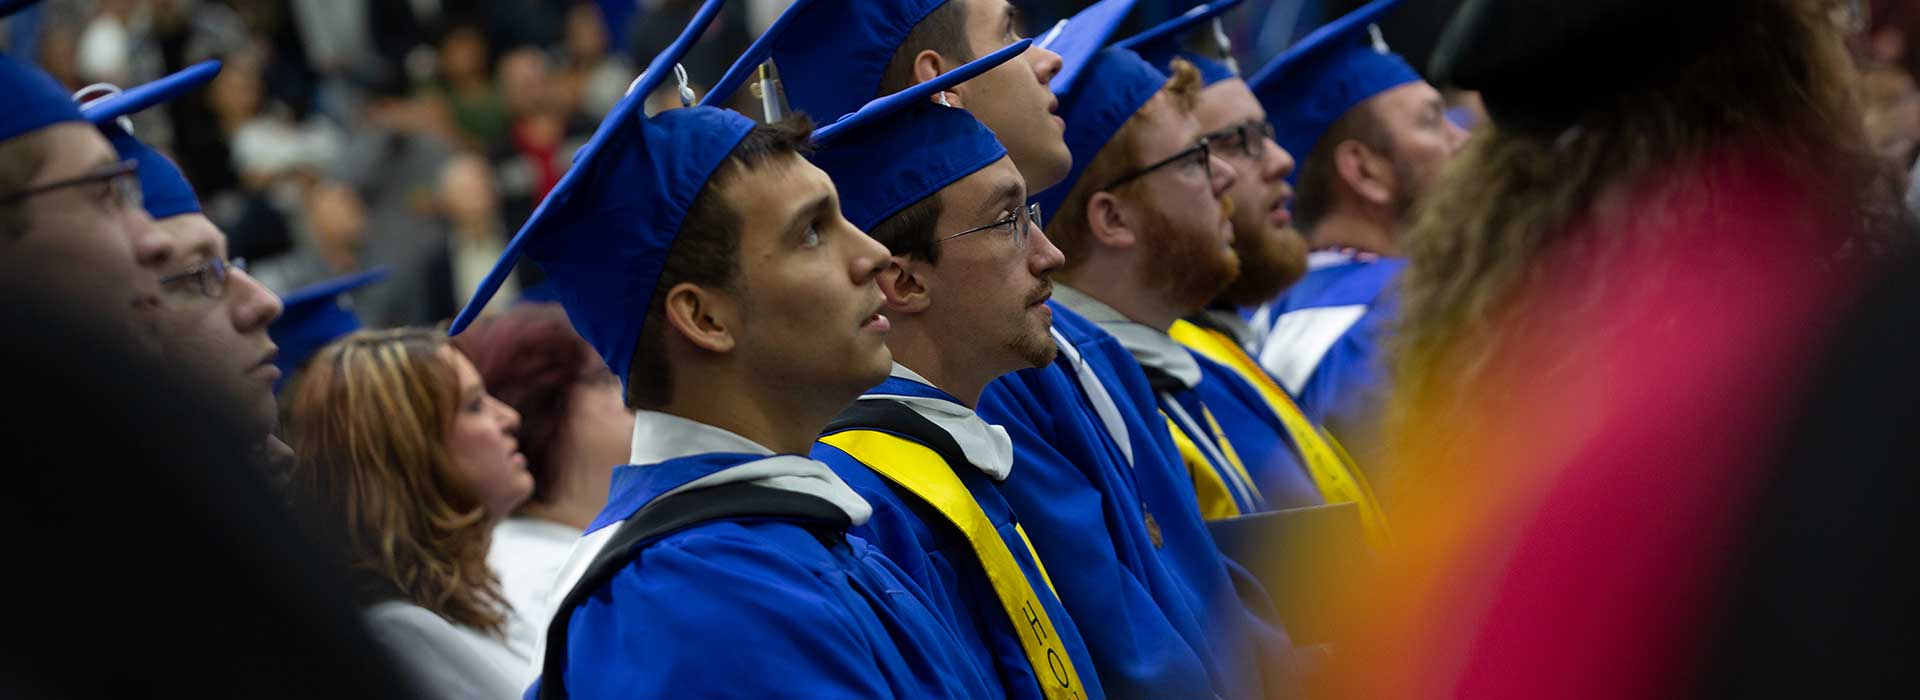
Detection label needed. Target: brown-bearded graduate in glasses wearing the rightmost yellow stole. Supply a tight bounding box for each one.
[1116,0,1386,545]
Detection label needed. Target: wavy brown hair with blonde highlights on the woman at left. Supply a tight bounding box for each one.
[284,328,507,637]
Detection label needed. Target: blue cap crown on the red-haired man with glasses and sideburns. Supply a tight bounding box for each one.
[1031,48,1167,221]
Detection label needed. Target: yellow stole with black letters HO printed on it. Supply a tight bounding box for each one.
[820,430,1087,700]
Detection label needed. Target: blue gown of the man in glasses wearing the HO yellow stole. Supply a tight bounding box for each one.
[812,376,1106,700]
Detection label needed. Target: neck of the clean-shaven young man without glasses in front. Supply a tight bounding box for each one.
[660,368,840,455]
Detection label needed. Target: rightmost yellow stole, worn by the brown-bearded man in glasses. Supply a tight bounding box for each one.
[1167,320,1392,547]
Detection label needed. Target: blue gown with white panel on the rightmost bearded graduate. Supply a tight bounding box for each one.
[1252,253,1407,426]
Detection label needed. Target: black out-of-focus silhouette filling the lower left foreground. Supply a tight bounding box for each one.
[0,253,415,700]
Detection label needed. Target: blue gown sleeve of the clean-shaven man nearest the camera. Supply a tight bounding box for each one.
[566,521,906,700]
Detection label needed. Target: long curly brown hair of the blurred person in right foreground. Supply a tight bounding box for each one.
[1388,0,1901,437]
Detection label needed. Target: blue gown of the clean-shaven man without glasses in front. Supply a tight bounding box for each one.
[528,455,993,700]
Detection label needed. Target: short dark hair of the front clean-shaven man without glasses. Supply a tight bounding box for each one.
[626,113,814,408]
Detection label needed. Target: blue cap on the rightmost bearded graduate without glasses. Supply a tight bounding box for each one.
[1246,0,1421,171]
